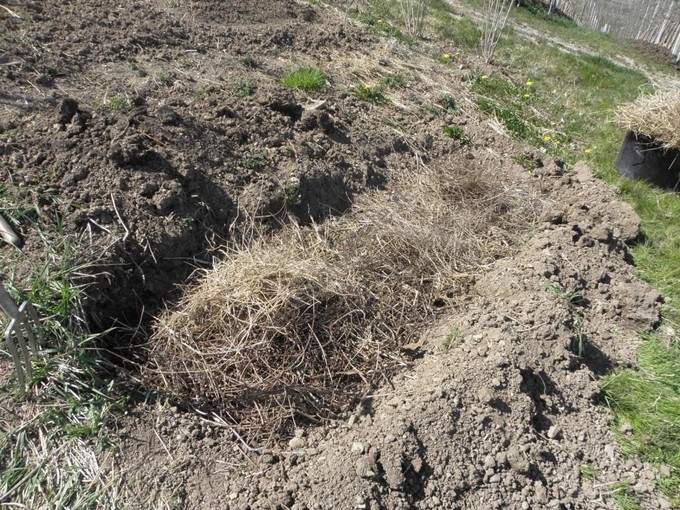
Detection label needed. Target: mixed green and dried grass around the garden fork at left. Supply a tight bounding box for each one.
[0,216,125,510]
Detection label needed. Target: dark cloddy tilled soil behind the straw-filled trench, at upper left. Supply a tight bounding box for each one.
[0,1,418,326]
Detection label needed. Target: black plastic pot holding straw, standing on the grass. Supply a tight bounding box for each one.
[616,131,680,188]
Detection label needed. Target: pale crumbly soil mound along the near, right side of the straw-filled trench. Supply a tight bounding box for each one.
[114,162,668,509]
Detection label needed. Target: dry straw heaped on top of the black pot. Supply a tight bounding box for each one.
[616,88,680,149]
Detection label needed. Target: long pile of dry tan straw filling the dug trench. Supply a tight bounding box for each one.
[145,161,533,437]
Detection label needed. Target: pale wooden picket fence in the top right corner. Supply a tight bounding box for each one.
[543,0,680,61]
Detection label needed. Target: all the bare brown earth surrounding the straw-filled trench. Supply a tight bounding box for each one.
[0,0,669,510]
